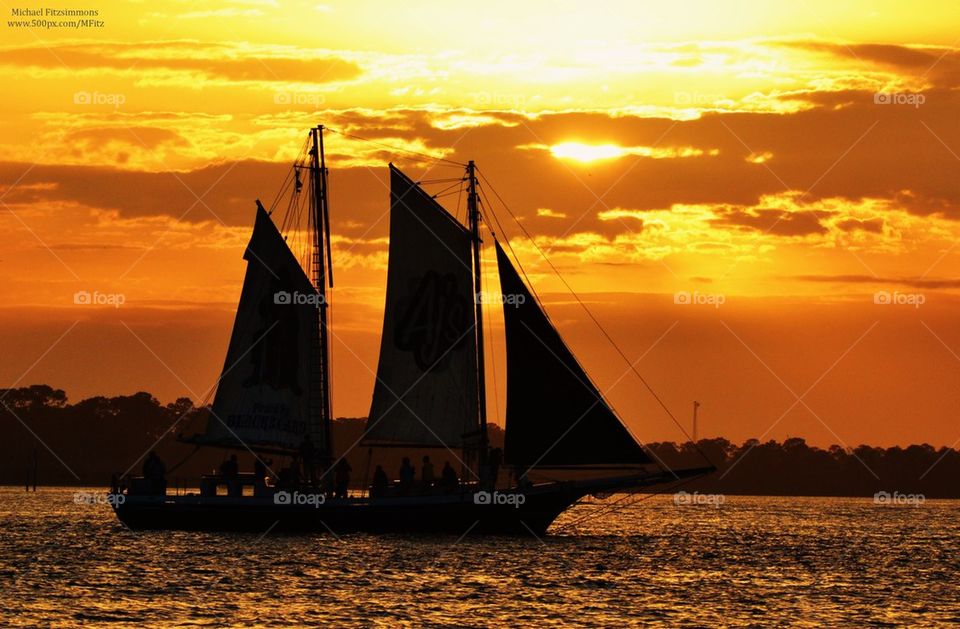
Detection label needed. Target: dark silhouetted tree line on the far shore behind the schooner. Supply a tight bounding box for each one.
[0,385,960,498]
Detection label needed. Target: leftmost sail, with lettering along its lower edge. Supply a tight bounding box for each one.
[198,207,323,449]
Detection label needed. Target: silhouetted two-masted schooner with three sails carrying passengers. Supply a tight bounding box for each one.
[110,126,713,535]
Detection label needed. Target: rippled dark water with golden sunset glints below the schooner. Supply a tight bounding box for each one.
[0,488,960,627]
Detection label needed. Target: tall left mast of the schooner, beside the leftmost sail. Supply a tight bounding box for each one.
[310,125,333,460]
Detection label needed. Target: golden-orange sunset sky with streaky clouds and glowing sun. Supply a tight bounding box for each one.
[0,0,960,446]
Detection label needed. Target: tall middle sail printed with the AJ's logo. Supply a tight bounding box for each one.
[364,165,479,447]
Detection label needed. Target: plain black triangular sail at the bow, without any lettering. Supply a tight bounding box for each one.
[496,243,650,467]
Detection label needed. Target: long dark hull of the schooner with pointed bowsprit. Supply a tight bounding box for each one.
[111,467,713,535]
